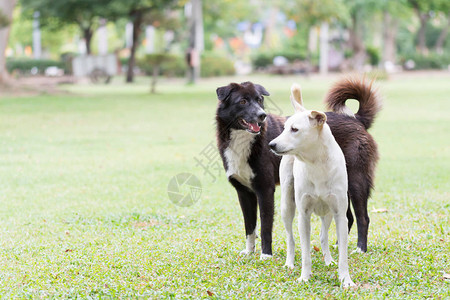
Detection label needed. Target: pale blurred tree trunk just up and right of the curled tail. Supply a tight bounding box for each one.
[383,11,398,68]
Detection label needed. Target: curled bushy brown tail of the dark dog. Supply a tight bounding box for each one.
[325,78,381,129]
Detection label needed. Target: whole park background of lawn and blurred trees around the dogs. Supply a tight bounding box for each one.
[0,0,450,299]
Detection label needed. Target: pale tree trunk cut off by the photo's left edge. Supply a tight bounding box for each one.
[0,0,16,85]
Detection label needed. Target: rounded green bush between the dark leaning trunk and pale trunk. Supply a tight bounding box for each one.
[137,54,187,77]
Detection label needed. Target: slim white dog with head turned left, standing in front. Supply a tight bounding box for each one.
[269,84,355,287]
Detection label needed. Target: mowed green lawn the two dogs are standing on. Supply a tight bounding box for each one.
[0,73,450,299]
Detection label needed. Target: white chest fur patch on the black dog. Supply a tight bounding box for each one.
[224,129,255,189]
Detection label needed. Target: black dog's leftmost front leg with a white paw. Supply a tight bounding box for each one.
[230,179,258,255]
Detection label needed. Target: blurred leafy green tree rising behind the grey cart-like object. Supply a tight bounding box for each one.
[20,0,111,54]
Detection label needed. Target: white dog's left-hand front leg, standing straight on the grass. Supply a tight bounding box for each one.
[298,211,311,282]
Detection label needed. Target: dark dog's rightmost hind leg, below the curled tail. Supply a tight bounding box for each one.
[348,179,370,253]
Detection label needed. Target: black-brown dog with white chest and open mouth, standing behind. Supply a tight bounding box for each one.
[216,79,380,259]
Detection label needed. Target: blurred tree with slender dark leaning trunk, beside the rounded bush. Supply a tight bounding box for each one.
[104,0,177,82]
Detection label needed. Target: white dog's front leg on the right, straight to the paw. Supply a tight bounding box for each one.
[334,213,355,288]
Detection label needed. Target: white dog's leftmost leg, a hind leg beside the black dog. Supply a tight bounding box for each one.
[280,155,295,269]
